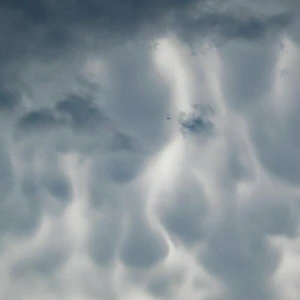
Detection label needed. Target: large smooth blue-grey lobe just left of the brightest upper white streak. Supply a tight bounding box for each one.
[104,43,171,150]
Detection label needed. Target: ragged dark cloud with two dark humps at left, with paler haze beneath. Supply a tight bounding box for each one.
[15,95,138,153]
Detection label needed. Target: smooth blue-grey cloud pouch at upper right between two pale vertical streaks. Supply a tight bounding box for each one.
[221,39,280,112]
